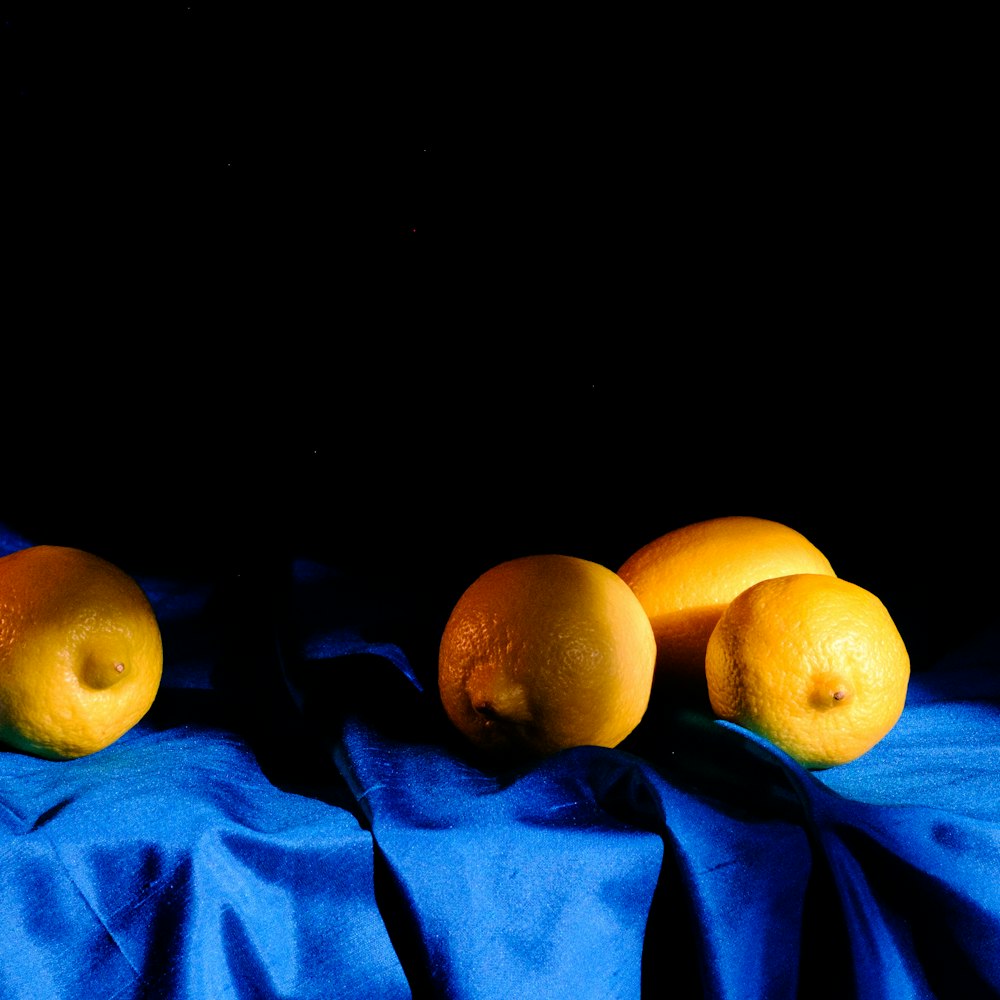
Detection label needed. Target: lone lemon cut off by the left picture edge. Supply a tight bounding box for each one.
[0,545,163,760]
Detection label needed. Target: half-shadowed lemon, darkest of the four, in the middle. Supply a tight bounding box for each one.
[438,555,656,756]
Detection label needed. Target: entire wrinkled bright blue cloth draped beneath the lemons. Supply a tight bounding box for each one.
[0,527,1000,1000]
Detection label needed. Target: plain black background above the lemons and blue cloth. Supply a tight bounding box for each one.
[0,4,997,663]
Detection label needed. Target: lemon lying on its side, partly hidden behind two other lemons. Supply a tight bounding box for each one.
[618,517,835,687]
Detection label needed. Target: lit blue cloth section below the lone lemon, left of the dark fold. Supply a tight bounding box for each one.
[0,729,410,1000]
